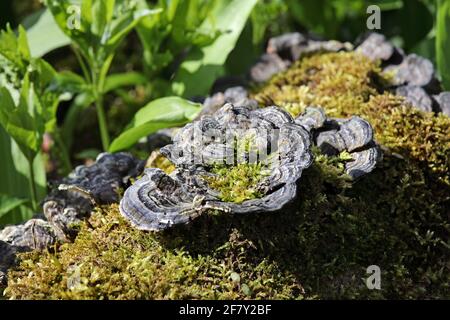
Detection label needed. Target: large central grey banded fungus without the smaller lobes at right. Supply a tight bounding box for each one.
[120,104,312,230]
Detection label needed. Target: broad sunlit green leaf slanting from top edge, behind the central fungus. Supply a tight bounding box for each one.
[173,0,257,97]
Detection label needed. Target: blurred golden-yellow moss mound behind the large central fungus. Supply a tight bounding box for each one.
[255,52,388,116]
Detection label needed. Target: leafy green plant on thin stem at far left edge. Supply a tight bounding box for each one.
[0,27,59,219]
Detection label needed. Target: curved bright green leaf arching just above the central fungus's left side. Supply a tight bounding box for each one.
[109,97,201,152]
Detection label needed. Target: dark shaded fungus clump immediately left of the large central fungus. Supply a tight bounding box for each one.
[43,153,145,241]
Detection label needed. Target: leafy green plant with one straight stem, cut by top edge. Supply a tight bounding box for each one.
[45,0,160,150]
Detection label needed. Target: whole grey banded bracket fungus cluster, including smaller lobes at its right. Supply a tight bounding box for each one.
[120,103,379,231]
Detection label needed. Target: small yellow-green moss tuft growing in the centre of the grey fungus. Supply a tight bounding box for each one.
[204,163,265,203]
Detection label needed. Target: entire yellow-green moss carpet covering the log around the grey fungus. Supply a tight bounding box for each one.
[6,53,450,299]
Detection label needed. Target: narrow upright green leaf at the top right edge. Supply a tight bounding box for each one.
[436,0,450,90]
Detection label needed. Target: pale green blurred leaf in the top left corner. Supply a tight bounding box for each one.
[24,9,70,57]
